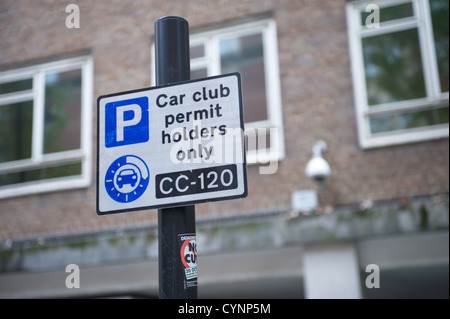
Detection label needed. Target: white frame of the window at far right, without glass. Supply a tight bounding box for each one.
[347,0,449,148]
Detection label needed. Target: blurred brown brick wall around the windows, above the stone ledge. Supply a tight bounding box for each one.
[0,0,449,239]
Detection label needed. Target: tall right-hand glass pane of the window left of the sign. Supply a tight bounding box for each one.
[44,69,81,154]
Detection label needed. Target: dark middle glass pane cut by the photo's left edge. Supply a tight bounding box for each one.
[0,101,33,163]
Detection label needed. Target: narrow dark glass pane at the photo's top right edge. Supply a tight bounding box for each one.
[430,0,449,92]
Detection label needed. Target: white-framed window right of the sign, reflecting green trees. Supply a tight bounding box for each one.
[347,0,449,148]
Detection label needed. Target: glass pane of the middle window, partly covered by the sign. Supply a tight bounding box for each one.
[220,33,268,122]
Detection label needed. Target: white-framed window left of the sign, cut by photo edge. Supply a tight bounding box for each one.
[0,57,92,198]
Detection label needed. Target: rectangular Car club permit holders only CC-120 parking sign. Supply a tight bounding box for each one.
[97,73,247,215]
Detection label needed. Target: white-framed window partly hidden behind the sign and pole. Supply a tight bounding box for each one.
[153,20,284,164]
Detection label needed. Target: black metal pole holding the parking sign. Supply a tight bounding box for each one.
[155,17,197,299]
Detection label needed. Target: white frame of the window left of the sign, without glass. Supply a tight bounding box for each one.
[0,56,93,198]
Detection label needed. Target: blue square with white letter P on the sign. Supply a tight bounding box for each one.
[105,96,149,147]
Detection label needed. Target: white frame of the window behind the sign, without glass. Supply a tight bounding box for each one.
[152,19,285,164]
